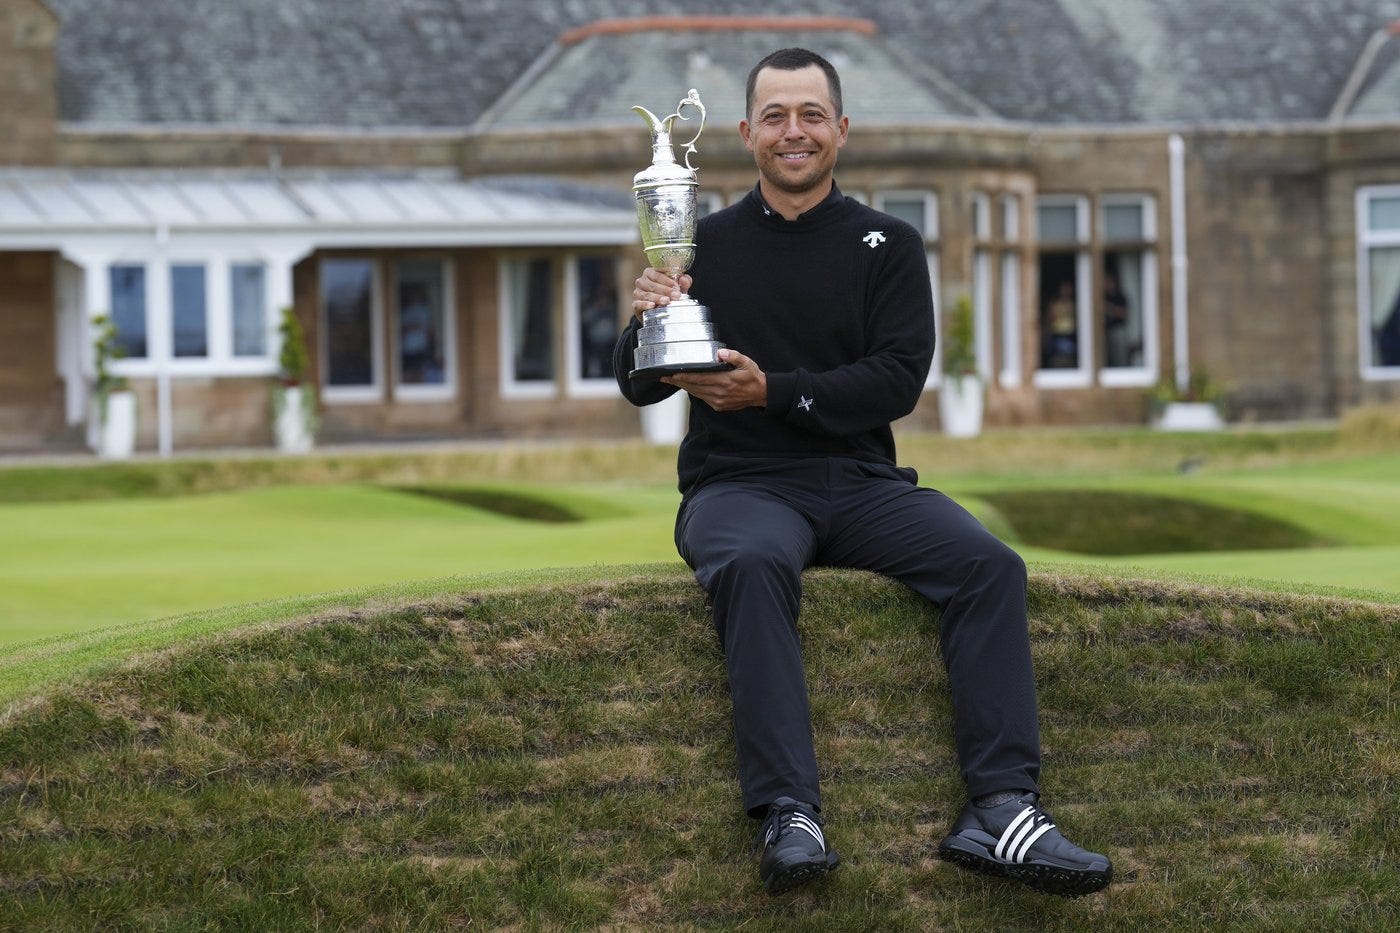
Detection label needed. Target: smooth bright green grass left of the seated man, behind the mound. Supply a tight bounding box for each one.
[0,485,679,644]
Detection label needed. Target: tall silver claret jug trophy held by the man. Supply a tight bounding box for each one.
[629,88,729,377]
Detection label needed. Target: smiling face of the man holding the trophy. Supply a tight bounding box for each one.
[739,64,850,220]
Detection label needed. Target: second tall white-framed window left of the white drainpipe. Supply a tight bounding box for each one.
[1036,195,1093,388]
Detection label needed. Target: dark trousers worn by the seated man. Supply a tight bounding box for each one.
[676,458,1040,814]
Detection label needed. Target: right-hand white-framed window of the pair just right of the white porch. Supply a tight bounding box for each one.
[391,259,455,401]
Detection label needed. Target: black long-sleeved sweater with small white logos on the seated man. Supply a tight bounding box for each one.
[613,185,934,493]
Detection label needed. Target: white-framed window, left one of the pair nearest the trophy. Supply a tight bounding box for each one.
[501,258,554,398]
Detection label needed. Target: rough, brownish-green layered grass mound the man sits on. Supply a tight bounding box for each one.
[0,572,1400,930]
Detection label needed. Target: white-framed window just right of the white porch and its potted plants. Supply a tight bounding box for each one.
[321,259,382,402]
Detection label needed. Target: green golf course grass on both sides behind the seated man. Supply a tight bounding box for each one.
[0,433,1400,644]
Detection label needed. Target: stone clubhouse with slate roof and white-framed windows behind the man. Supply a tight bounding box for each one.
[0,0,1400,452]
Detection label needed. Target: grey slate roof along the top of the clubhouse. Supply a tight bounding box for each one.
[45,0,1400,130]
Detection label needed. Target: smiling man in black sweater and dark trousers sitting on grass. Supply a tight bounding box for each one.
[613,49,1112,897]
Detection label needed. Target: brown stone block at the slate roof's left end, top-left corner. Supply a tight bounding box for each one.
[0,0,59,165]
